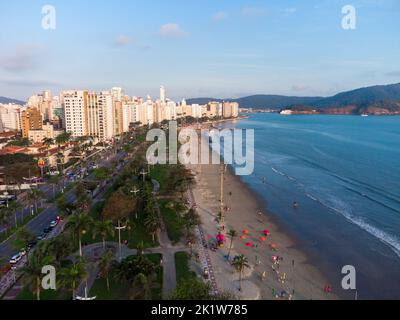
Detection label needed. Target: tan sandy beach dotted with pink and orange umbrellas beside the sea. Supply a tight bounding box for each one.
[189,125,337,300]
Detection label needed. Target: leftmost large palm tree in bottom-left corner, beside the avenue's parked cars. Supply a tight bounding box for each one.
[18,245,55,300]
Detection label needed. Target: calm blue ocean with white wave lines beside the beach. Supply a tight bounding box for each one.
[223,114,400,299]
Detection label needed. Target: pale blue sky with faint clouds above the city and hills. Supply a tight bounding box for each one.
[0,0,400,100]
